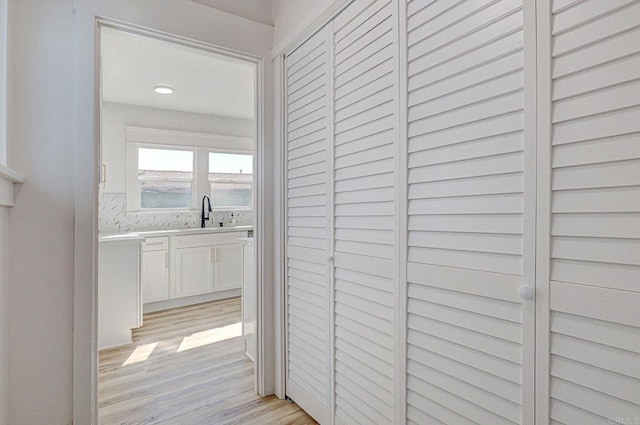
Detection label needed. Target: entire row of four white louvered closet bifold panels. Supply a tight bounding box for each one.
[284,0,640,425]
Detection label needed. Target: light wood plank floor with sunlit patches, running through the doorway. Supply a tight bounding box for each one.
[98,298,316,425]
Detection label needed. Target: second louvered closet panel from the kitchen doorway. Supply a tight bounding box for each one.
[333,0,397,425]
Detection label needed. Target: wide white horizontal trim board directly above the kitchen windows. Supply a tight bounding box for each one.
[126,126,254,152]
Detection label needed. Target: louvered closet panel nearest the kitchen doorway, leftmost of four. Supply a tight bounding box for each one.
[285,24,331,423]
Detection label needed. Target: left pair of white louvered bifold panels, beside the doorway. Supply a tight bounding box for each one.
[285,0,398,425]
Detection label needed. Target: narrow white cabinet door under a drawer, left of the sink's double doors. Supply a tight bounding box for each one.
[142,250,169,303]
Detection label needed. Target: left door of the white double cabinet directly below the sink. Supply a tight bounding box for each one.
[175,246,214,298]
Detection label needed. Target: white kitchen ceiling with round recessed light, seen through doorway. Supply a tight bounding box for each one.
[101,28,255,119]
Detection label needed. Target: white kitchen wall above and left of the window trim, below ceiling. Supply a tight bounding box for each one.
[102,102,255,193]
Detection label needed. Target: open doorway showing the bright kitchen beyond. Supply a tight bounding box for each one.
[97,25,282,424]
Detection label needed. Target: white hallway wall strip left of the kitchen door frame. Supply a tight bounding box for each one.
[9,0,74,424]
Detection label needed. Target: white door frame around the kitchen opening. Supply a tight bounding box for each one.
[73,12,273,424]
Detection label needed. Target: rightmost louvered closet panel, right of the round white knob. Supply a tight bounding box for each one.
[540,0,640,425]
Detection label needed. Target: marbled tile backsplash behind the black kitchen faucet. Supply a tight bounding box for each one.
[98,193,253,233]
